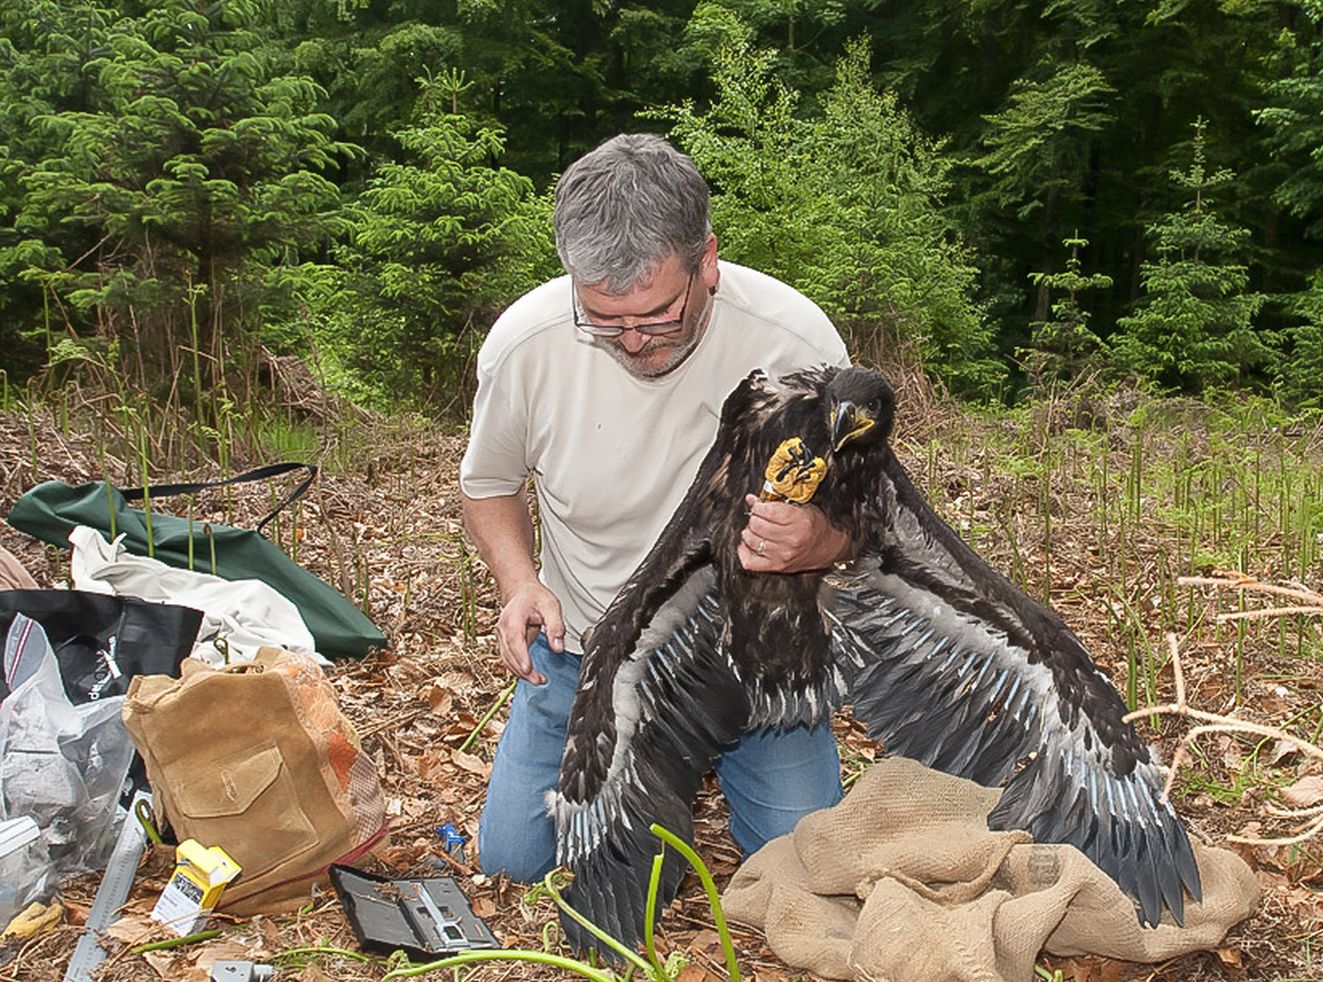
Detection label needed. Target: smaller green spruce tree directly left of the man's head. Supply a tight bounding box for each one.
[336,74,557,410]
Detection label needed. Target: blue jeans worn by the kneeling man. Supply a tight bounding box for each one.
[478,635,841,883]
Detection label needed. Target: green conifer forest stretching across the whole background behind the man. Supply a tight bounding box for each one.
[0,0,1323,418]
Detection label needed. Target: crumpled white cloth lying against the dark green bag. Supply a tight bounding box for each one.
[69,525,322,667]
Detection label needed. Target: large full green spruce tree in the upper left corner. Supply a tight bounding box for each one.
[0,0,359,388]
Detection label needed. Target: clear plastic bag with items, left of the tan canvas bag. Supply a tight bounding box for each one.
[0,614,134,903]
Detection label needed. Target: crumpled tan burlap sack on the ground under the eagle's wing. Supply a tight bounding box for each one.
[722,757,1258,982]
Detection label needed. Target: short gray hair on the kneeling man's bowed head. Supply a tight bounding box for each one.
[554,134,712,294]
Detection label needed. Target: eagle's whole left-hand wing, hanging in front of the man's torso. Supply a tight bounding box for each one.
[549,373,774,948]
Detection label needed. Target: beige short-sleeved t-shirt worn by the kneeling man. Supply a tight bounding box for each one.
[459,262,848,652]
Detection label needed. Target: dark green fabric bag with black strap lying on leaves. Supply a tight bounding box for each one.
[9,463,386,658]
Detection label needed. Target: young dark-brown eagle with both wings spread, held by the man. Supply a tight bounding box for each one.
[548,368,1200,948]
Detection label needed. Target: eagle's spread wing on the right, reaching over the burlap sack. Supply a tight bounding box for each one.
[828,458,1201,924]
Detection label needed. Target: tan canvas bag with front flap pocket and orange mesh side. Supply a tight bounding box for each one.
[123,648,386,915]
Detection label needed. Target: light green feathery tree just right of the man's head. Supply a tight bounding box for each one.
[651,35,1005,397]
